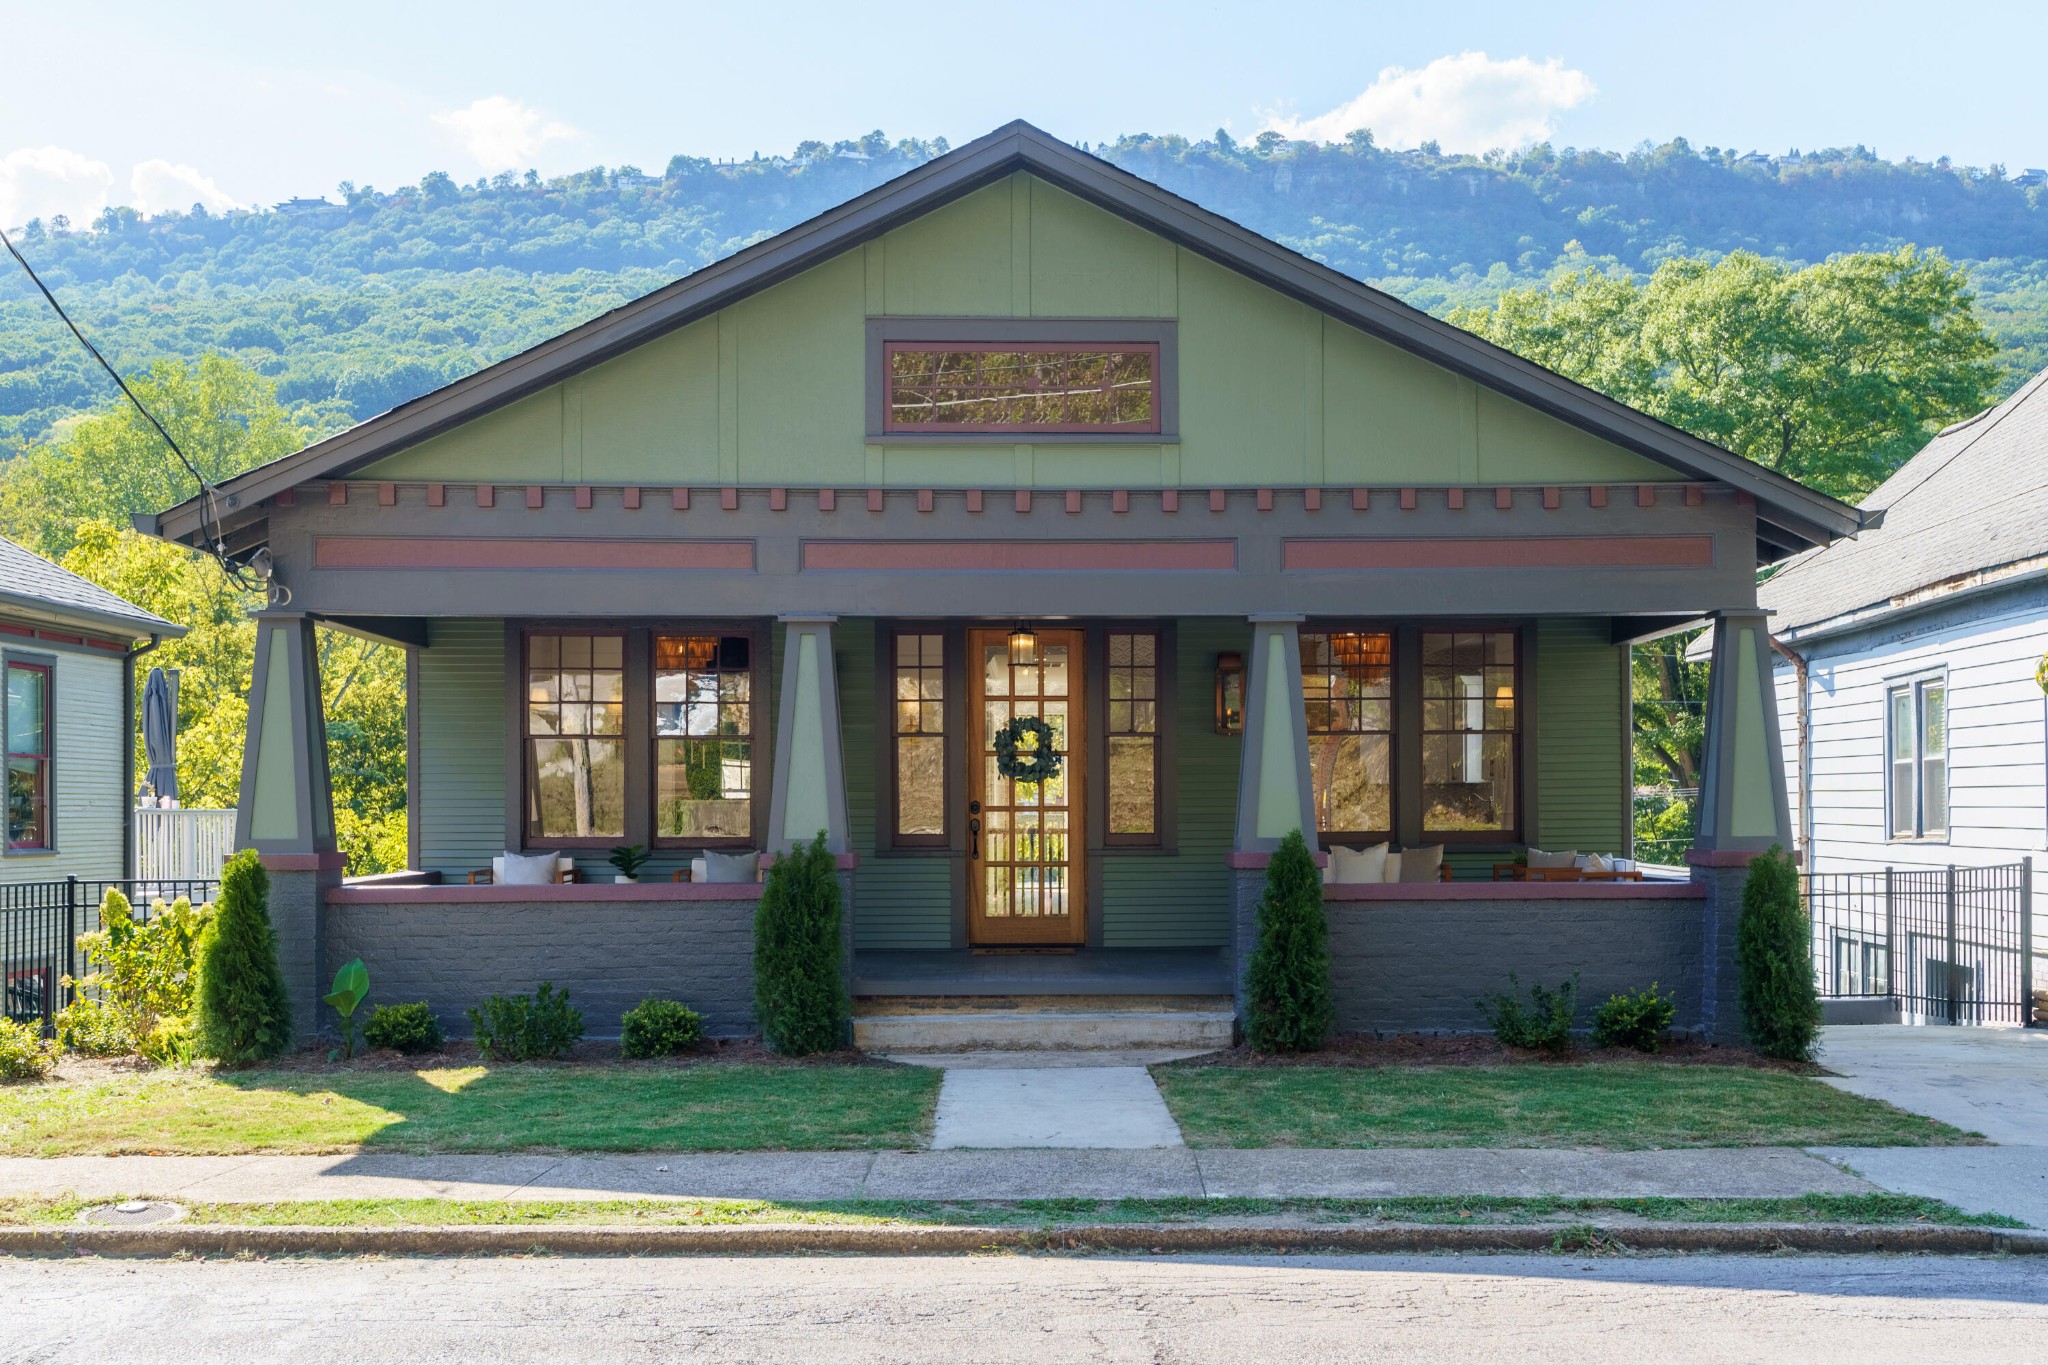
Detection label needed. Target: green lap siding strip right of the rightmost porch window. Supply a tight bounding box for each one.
[1532,618,1628,853]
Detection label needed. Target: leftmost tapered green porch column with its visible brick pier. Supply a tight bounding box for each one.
[236,616,344,1038]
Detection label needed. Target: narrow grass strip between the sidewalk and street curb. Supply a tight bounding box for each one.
[0,1193,2023,1230]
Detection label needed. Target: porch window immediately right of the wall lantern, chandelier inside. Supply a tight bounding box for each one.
[1300,630,1395,839]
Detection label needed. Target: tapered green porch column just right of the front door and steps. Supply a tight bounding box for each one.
[1237,616,1315,853]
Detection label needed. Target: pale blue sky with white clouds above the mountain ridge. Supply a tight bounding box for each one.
[0,0,2048,225]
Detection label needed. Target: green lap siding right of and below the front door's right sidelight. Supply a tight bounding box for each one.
[1096,620,1251,948]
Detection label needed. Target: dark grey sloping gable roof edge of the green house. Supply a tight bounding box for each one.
[137,121,1866,561]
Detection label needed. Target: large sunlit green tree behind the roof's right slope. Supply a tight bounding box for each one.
[1452,246,1999,501]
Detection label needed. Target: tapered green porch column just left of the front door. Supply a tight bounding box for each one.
[764,616,852,853]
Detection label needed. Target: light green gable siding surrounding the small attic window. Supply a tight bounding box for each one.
[360,174,1671,487]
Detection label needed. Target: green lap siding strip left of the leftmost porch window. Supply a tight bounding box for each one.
[414,620,506,878]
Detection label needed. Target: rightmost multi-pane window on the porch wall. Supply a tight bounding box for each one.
[1421,630,1518,833]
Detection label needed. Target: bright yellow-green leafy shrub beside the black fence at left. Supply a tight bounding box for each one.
[57,888,213,1064]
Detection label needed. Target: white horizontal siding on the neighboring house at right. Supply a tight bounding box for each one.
[1778,587,2048,888]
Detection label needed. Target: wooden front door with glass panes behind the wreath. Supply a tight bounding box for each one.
[965,630,1087,945]
